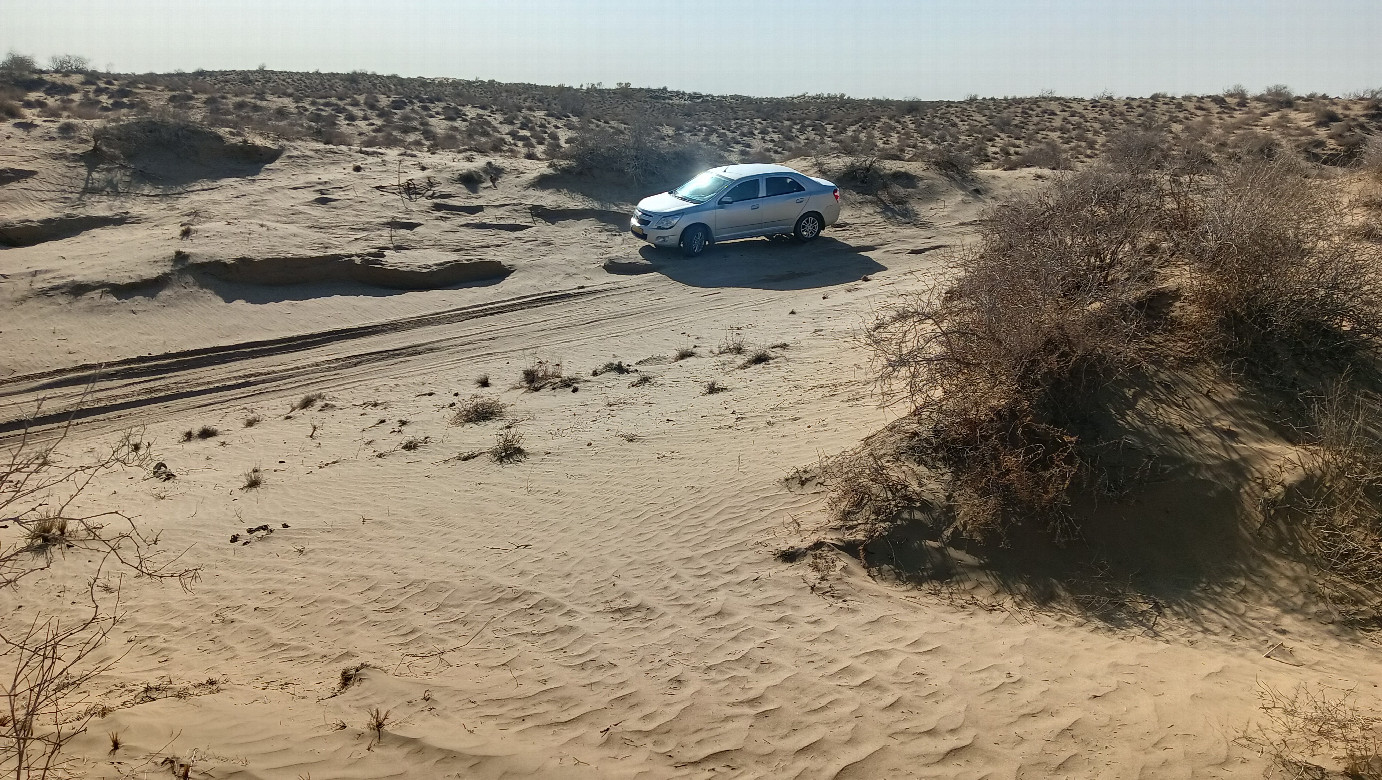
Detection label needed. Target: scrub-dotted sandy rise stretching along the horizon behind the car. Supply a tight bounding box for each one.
[0,54,1382,185]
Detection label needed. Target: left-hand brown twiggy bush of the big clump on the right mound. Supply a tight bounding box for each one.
[864,170,1158,539]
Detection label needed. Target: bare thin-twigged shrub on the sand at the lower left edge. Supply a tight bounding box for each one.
[0,427,198,779]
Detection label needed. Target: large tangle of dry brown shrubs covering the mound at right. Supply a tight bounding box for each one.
[825,126,1382,625]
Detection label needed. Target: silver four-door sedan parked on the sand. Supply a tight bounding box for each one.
[629,165,840,257]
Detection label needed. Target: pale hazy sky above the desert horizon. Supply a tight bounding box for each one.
[0,0,1382,100]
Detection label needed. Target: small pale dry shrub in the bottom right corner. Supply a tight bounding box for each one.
[1237,685,1382,780]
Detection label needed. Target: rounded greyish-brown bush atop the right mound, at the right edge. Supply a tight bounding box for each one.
[1183,162,1382,357]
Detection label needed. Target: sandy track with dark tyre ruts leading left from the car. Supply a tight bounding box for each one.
[0,268,829,436]
